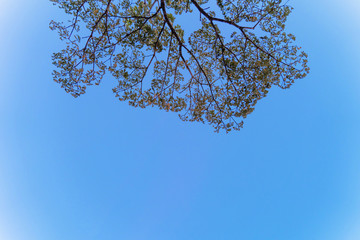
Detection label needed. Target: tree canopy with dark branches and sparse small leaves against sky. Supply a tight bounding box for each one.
[50,0,309,132]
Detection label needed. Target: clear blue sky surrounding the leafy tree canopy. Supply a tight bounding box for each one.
[0,0,360,240]
